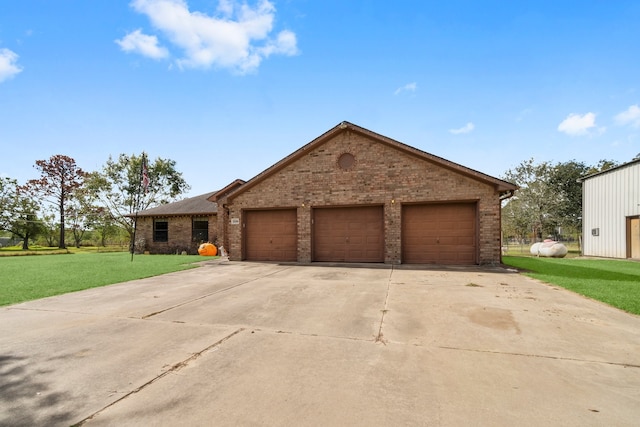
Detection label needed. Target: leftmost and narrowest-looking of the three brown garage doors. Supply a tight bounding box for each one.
[244,209,298,261]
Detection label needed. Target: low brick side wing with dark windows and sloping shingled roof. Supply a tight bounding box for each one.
[136,193,218,254]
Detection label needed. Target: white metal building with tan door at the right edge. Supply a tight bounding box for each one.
[581,159,640,259]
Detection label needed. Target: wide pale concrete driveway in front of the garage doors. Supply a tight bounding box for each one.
[0,261,640,426]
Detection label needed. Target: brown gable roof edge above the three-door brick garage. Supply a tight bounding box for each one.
[215,121,518,200]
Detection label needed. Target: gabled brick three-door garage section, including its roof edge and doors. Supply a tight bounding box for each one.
[212,122,516,265]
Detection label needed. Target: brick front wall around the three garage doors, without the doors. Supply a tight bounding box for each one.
[227,130,500,264]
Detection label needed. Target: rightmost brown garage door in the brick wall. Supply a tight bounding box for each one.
[402,203,477,264]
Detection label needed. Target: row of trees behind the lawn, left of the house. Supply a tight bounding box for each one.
[0,152,190,250]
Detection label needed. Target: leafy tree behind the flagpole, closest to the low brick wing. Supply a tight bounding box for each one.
[88,153,190,246]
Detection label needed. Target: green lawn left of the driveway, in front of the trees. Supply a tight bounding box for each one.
[0,252,203,306]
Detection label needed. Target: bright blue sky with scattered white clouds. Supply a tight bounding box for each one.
[0,0,640,196]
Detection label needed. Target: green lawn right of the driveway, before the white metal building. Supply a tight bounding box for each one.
[502,256,640,314]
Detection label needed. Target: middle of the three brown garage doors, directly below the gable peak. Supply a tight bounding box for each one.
[313,206,384,262]
